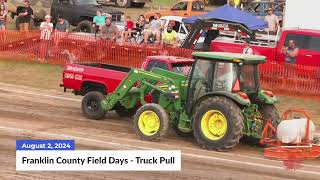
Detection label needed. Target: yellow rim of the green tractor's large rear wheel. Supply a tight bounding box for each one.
[201,110,228,141]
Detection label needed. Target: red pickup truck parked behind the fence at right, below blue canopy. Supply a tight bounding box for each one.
[181,20,320,67]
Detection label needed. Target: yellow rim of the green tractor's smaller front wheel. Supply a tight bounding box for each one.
[138,111,160,136]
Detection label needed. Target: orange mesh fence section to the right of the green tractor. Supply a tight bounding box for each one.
[259,61,320,97]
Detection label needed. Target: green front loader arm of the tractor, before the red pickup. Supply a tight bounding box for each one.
[101,69,179,110]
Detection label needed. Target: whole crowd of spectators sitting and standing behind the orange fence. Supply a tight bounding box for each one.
[0,0,299,63]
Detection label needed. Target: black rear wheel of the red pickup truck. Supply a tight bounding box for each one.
[81,91,105,120]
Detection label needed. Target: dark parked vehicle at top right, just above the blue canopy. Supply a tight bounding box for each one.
[243,0,285,24]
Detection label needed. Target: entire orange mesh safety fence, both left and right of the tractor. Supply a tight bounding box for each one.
[0,31,320,97]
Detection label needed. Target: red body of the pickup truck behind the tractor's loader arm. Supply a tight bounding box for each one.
[61,56,193,96]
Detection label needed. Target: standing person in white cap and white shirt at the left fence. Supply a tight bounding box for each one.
[39,15,53,63]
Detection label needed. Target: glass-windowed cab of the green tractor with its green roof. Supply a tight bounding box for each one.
[187,52,266,108]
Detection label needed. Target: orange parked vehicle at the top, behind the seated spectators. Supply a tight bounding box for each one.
[144,0,206,20]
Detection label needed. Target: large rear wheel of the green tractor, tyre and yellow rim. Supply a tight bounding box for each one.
[193,96,244,151]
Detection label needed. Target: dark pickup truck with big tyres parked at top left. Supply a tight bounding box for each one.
[51,0,124,33]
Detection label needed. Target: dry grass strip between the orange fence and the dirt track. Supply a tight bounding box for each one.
[0,60,320,127]
